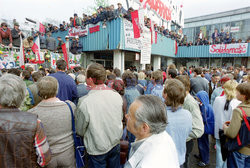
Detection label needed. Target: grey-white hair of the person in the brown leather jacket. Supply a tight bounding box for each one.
[0,74,26,108]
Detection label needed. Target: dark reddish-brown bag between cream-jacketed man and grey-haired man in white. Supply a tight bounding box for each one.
[120,128,129,165]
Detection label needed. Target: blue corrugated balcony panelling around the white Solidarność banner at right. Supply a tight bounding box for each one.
[176,43,250,58]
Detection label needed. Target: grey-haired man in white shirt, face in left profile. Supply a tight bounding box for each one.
[125,95,179,168]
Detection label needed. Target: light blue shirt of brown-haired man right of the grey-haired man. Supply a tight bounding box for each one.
[166,106,192,165]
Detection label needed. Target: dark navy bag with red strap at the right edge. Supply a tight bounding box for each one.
[225,107,250,152]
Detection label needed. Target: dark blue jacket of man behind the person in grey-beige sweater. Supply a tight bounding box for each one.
[49,71,77,102]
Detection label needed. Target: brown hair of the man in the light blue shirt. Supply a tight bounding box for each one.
[163,79,186,111]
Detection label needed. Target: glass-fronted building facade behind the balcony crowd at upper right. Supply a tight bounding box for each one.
[183,7,250,43]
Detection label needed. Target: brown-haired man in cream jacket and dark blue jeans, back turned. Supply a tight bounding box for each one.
[75,63,123,168]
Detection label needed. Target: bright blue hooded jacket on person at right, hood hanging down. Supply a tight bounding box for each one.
[196,91,214,135]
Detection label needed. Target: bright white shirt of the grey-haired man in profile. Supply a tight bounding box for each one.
[125,131,180,168]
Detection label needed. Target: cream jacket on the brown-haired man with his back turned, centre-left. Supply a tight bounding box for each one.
[76,88,123,155]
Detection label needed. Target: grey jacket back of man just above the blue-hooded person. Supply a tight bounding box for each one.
[190,76,209,96]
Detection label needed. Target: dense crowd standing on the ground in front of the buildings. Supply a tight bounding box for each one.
[0,60,250,168]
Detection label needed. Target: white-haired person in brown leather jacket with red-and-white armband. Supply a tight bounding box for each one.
[0,74,51,168]
